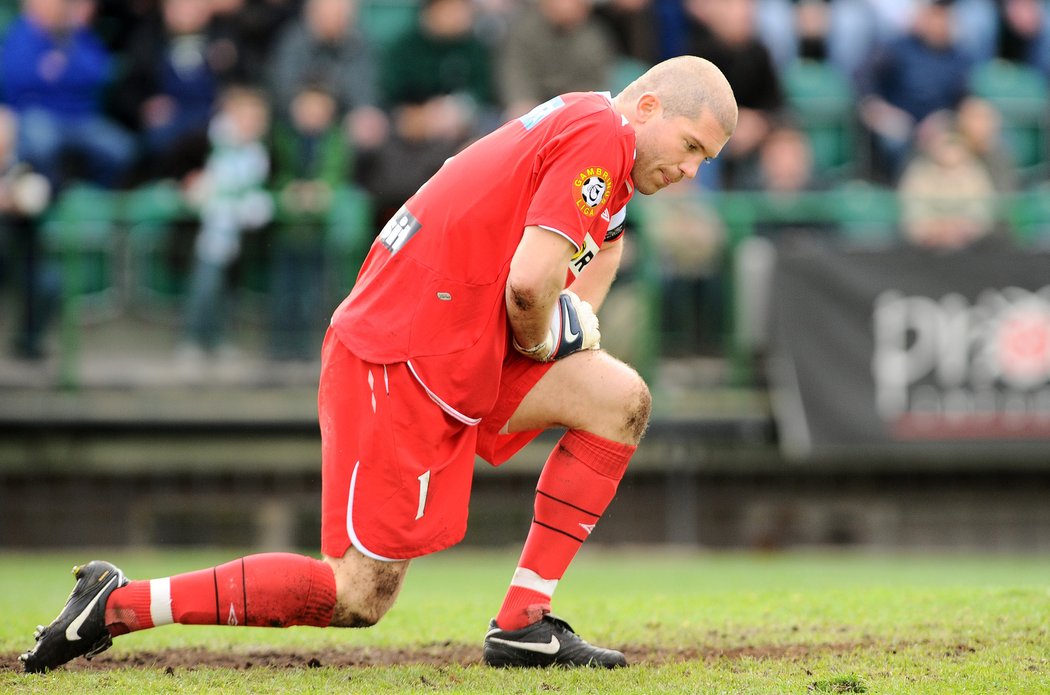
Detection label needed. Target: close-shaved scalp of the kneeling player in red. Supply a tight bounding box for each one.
[616,56,737,135]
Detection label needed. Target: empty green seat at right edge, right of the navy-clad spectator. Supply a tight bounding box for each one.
[970,60,1050,181]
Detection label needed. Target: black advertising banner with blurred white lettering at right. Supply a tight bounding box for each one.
[770,246,1050,465]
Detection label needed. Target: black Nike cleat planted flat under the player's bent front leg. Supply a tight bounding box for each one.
[485,615,627,669]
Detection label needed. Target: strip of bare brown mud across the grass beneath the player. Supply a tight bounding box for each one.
[0,643,873,672]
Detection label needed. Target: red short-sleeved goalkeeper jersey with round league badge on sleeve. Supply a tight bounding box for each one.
[332,92,634,424]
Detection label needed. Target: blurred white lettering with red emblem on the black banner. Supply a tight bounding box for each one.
[872,286,1050,428]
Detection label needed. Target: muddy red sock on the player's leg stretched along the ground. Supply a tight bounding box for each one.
[106,552,335,636]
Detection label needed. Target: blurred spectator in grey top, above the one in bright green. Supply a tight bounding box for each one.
[269,0,386,147]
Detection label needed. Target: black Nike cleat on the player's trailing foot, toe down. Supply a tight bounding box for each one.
[18,560,128,673]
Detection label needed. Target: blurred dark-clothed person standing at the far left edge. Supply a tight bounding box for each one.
[0,109,60,359]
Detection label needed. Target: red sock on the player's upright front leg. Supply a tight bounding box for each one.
[496,429,635,630]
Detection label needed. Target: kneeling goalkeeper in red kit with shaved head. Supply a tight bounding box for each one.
[20,57,737,672]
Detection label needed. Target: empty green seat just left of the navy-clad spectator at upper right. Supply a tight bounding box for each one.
[781,60,857,177]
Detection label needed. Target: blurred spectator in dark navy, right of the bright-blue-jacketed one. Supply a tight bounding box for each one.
[113,0,218,178]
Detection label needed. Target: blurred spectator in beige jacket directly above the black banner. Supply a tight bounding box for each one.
[897,113,995,250]
